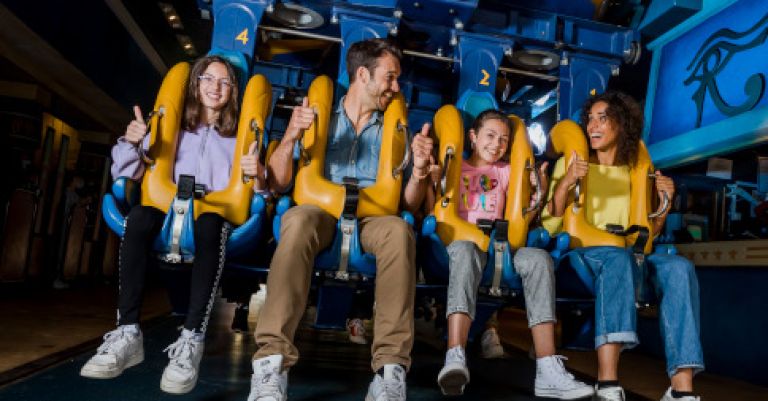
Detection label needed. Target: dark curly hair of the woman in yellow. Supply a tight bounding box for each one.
[581,91,644,167]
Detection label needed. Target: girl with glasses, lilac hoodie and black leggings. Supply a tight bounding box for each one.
[80,56,264,394]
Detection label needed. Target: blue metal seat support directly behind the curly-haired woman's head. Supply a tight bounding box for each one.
[558,54,619,121]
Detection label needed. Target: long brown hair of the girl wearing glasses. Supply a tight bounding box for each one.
[182,56,240,137]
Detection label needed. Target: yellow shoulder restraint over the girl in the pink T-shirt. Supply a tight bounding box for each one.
[433,105,542,250]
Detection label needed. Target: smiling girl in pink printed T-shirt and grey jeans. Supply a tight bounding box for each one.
[437,110,593,400]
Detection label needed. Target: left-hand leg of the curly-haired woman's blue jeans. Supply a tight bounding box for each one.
[571,246,638,349]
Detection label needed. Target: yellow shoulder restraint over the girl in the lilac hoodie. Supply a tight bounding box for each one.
[141,62,272,225]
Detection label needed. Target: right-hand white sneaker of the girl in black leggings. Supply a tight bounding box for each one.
[160,329,205,394]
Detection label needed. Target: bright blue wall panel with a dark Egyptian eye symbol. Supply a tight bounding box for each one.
[646,0,768,167]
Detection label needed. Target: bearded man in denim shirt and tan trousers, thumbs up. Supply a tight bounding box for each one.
[248,39,432,401]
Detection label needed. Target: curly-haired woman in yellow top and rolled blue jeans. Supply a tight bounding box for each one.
[543,92,704,401]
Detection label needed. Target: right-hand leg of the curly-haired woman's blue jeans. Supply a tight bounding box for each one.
[646,254,704,377]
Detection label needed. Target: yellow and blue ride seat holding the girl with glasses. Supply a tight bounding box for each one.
[102,63,271,263]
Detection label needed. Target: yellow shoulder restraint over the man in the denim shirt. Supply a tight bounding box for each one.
[293,75,409,218]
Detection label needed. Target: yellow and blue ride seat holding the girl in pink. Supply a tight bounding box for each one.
[420,105,548,297]
